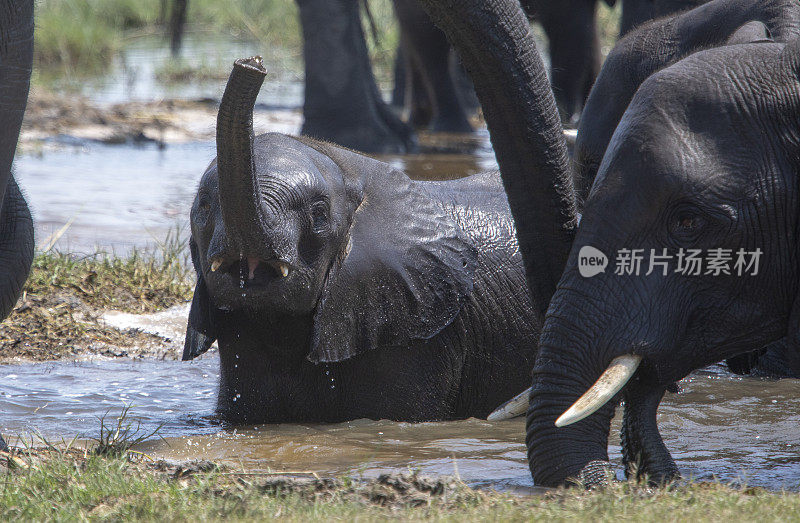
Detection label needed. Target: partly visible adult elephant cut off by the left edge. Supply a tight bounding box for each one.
[0,0,33,450]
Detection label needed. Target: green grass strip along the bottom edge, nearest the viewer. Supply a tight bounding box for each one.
[0,451,800,521]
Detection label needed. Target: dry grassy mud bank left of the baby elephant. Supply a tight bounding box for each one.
[0,252,192,363]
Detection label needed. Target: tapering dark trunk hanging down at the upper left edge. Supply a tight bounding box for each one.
[0,0,33,215]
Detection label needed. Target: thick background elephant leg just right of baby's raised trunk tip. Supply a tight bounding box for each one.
[297,0,416,153]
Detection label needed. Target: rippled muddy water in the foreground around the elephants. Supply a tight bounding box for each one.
[0,354,800,490]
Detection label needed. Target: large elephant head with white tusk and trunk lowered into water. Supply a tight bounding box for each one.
[527,41,800,485]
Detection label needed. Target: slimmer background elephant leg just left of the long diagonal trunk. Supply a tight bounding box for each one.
[394,0,473,133]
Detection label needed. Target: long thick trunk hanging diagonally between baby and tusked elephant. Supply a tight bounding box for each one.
[421,0,577,314]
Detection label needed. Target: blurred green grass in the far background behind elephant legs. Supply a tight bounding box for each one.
[35,0,398,80]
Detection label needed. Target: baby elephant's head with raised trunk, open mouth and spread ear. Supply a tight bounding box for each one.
[184,58,476,362]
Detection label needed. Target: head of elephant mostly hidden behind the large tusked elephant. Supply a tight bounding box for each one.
[574,0,800,199]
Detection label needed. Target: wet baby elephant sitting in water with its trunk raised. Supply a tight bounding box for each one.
[183,58,540,424]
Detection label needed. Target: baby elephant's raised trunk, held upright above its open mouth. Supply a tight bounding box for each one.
[217,57,267,251]
